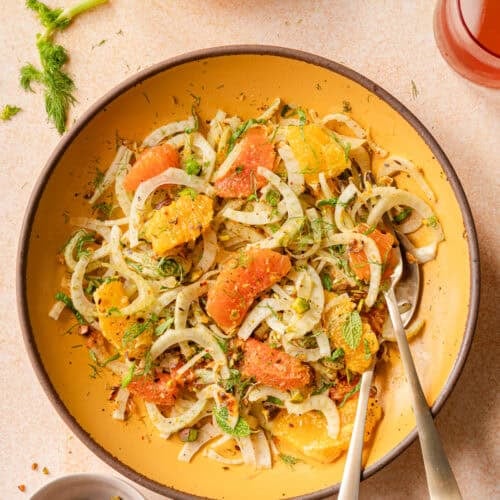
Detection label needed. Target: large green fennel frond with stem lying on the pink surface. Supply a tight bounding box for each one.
[20,0,107,134]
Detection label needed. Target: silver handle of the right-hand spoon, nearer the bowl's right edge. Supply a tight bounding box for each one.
[384,288,462,500]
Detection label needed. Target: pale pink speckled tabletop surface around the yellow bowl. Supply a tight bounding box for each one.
[0,0,500,500]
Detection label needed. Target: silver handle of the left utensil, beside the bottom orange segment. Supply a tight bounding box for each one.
[338,366,373,500]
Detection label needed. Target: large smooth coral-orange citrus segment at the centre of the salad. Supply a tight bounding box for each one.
[207,249,291,331]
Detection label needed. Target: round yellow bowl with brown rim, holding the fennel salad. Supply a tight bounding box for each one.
[18,46,479,500]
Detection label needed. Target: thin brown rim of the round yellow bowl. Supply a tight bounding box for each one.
[16,45,480,500]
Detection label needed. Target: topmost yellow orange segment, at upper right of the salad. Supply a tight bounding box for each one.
[287,123,350,184]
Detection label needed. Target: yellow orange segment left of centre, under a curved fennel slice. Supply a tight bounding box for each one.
[143,194,214,255]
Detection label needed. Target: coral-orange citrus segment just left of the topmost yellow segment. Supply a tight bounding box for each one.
[215,127,275,198]
